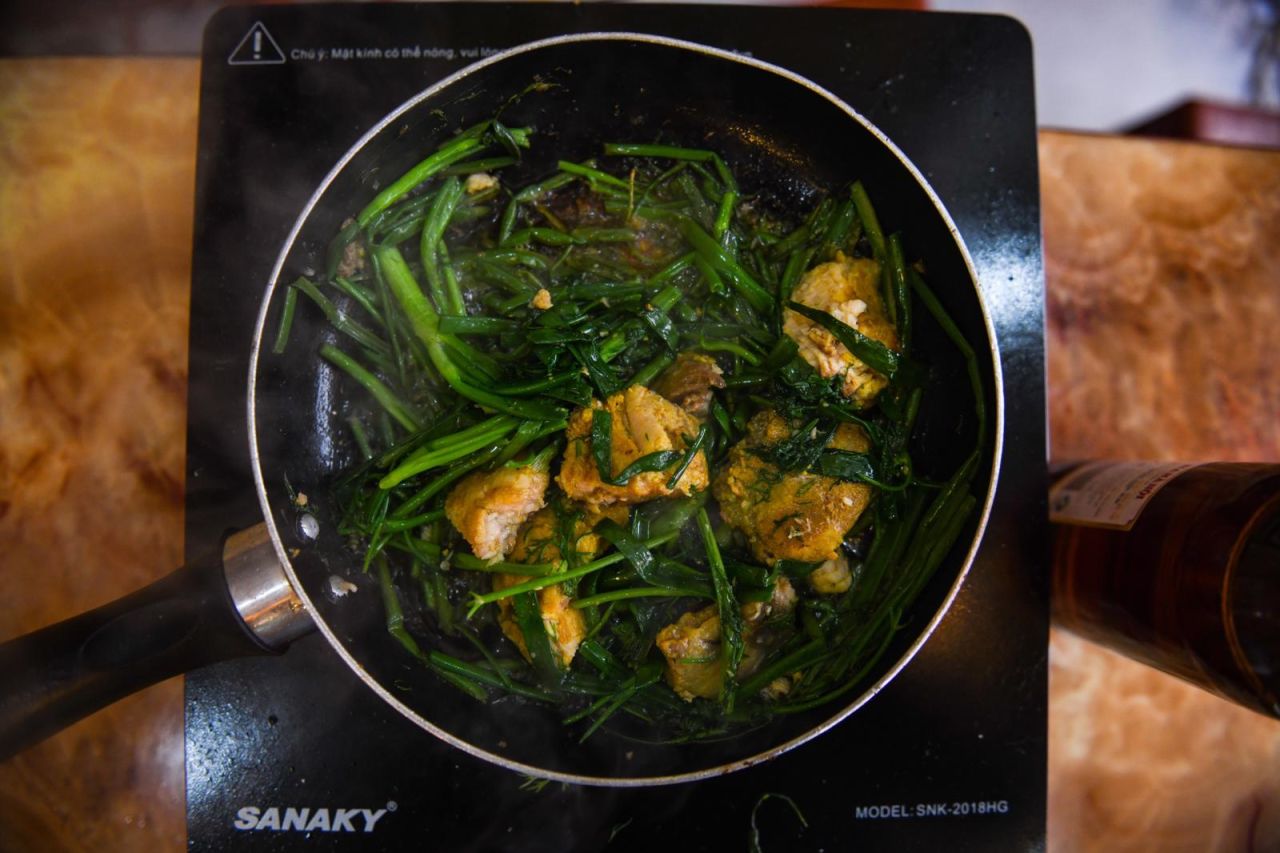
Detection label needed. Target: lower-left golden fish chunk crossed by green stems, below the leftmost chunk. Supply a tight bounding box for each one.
[493,505,627,666]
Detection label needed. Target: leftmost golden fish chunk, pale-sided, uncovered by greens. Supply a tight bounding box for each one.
[444,464,550,560]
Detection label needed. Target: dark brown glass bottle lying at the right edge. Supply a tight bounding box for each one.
[1050,462,1280,717]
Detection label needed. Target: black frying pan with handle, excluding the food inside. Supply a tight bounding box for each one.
[0,33,1004,785]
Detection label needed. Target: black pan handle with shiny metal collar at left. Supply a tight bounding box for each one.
[0,525,311,761]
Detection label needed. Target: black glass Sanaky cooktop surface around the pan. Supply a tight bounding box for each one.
[186,4,1048,850]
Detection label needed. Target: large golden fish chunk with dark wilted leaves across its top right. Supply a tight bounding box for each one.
[712,411,872,566]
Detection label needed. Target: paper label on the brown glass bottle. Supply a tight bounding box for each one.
[1048,462,1197,530]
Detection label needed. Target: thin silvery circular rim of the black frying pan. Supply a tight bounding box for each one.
[246,31,1005,788]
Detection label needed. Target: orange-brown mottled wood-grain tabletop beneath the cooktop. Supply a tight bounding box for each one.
[0,59,1280,852]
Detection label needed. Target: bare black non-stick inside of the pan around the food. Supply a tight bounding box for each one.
[253,38,998,780]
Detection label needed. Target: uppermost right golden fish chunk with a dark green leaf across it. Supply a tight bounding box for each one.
[782,255,900,406]
